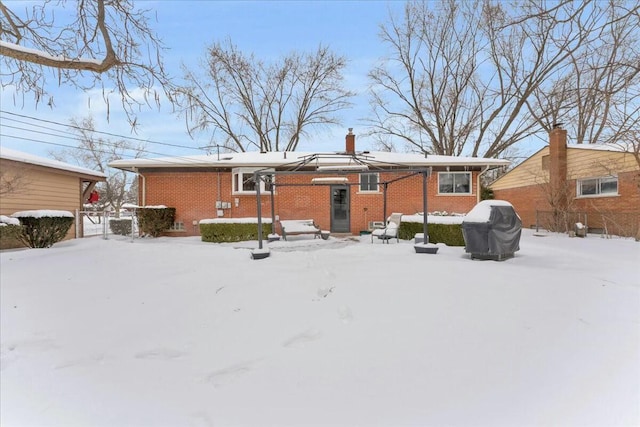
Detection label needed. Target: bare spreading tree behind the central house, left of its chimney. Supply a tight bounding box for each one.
[176,41,352,151]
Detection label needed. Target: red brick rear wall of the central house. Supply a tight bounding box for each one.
[139,171,478,236]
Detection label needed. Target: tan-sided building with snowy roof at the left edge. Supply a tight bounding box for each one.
[0,147,105,238]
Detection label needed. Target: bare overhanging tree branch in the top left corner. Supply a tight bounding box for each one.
[0,0,169,126]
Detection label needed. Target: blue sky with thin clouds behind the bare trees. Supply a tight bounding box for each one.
[0,0,404,157]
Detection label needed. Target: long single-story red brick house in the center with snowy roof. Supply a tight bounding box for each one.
[109,130,509,236]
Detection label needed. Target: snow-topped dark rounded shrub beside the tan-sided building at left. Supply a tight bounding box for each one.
[12,210,73,248]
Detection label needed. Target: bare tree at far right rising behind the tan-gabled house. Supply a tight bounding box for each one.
[527,0,640,144]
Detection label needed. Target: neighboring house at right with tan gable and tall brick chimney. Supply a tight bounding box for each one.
[490,127,640,237]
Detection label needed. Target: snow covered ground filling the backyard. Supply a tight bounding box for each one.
[0,230,640,427]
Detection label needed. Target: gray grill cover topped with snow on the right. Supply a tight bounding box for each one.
[462,206,522,259]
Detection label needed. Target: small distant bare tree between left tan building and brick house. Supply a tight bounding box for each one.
[51,117,145,215]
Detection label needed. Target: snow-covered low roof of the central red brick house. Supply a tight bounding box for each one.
[109,151,509,170]
